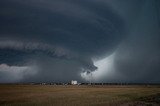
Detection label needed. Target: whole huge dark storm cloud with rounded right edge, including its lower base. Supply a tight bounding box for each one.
[0,0,125,81]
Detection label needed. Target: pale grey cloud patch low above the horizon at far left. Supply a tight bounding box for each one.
[0,64,37,83]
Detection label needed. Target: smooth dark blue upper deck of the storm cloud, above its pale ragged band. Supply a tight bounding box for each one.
[0,0,124,56]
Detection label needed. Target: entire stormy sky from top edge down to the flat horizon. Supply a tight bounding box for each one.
[0,0,160,83]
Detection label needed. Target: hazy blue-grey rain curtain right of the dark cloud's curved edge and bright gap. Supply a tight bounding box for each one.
[95,0,160,83]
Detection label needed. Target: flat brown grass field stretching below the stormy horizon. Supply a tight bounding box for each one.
[0,85,160,106]
